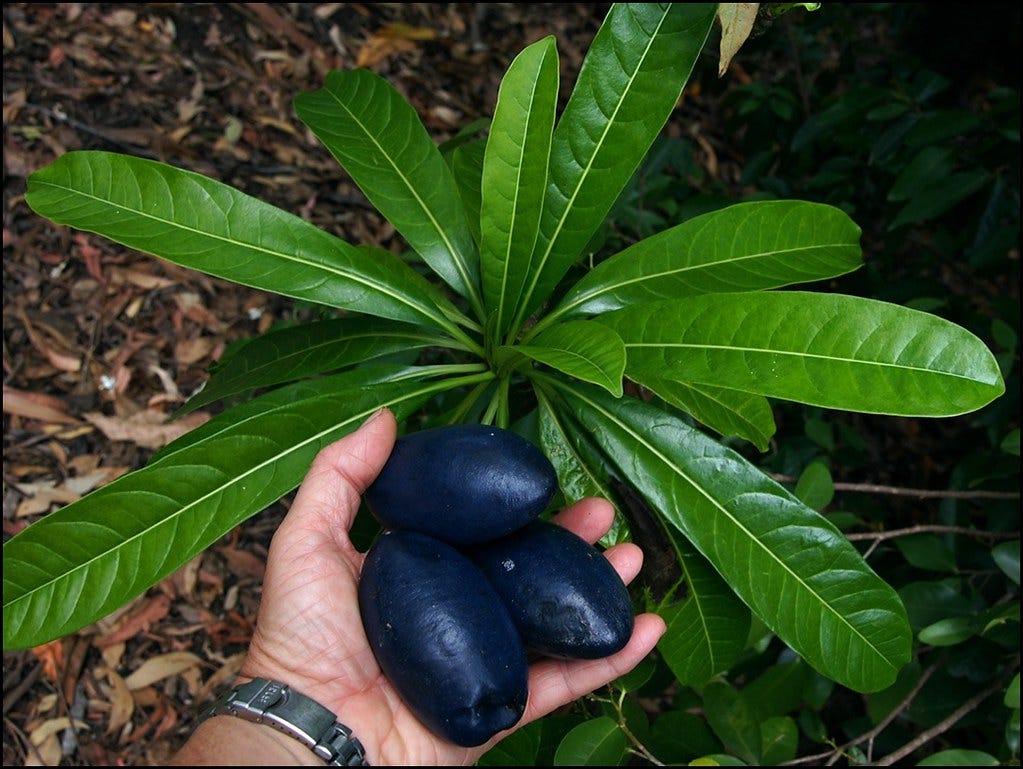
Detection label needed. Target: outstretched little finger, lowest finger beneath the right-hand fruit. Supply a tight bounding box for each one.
[521,614,667,724]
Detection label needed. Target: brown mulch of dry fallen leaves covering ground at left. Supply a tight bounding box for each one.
[3,3,607,766]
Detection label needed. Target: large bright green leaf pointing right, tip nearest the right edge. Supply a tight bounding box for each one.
[598,291,1005,416]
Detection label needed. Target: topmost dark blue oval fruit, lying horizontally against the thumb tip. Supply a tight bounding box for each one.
[364,424,558,545]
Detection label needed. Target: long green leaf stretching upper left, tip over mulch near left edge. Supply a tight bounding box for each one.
[26,151,470,339]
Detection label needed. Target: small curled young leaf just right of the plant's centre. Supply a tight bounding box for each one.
[515,320,625,396]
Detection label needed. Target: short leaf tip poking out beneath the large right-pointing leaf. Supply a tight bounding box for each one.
[636,371,774,451]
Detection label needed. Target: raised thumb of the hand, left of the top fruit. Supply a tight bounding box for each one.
[281,408,398,533]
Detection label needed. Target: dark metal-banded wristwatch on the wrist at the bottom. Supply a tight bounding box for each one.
[198,678,369,766]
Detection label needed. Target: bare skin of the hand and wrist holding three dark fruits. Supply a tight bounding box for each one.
[174,409,665,766]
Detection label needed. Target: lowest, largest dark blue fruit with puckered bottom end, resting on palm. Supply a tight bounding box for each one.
[359,531,528,748]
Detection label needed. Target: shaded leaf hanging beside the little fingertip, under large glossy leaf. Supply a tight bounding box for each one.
[657,531,750,686]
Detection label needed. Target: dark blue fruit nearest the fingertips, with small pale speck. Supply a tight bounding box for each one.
[465,519,634,660]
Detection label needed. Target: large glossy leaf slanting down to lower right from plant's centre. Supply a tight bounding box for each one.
[550,377,913,692]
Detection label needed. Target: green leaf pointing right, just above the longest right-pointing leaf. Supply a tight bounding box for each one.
[541,200,862,324]
